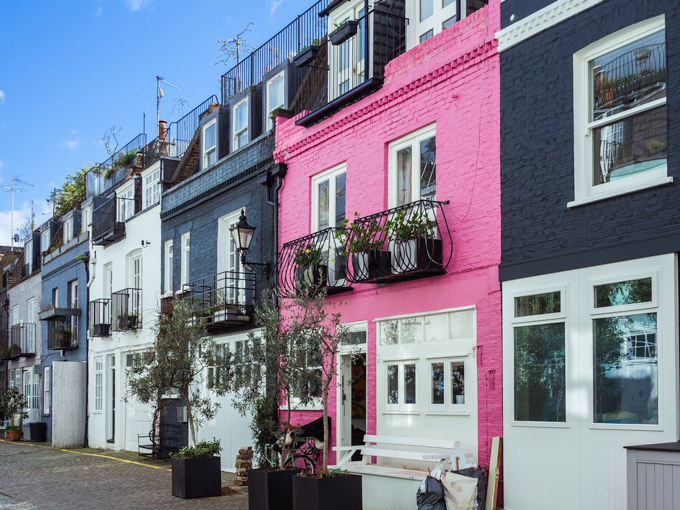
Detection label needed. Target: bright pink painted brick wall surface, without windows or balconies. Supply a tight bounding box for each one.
[275,0,502,466]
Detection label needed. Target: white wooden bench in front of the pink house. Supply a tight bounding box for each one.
[333,434,473,510]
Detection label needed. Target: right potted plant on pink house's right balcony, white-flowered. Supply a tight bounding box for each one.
[387,211,442,274]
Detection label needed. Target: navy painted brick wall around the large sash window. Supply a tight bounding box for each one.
[501,0,680,280]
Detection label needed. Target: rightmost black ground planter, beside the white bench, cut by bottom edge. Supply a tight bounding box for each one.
[293,475,363,510]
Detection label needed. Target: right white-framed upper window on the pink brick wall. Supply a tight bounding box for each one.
[388,124,437,207]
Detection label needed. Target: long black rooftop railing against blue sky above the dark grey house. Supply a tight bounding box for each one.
[222,0,328,105]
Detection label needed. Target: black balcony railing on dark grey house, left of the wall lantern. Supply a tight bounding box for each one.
[182,271,255,331]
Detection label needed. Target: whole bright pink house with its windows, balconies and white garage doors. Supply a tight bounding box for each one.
[275,1,502,466]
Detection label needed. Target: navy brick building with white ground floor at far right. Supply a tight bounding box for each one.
[497,0,680,509]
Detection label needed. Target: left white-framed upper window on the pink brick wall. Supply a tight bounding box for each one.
[312,163,347,232]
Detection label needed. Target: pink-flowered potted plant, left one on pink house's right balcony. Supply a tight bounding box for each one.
[346,212,391,282]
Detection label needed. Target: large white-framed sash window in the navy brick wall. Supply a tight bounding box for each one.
[570,17,669,205]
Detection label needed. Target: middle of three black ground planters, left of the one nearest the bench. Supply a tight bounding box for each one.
[248,469,299,510]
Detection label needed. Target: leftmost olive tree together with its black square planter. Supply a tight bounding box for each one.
[126,300,231,498]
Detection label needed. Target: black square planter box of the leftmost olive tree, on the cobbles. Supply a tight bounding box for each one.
[172,457,222,498]
